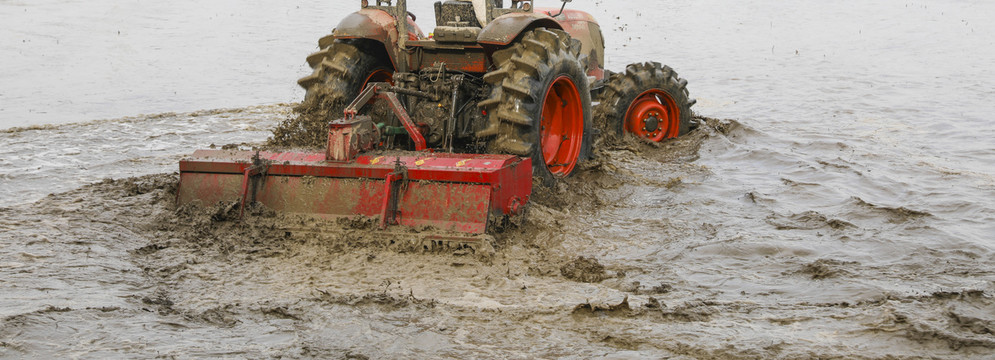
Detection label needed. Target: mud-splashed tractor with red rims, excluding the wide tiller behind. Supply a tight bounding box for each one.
[298,0,694,182]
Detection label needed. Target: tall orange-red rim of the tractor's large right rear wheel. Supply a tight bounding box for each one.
[540,76,584,177]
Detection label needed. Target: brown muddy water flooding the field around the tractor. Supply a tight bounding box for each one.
[0,1,995,359]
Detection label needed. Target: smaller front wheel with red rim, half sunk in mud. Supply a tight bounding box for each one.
[595,62,696,141]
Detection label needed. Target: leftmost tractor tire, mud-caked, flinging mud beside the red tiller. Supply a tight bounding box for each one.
[270,37,394,148]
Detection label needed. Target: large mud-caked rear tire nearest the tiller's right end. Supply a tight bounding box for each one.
[477,28,593,185]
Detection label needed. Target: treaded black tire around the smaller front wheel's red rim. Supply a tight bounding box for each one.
[595,62,696,140]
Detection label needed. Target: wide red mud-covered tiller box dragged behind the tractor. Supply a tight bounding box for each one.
[177,150,532,234]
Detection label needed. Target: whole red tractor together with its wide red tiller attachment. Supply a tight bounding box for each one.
[180,0,694,242]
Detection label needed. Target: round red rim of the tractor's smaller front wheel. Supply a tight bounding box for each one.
[625,89,681,141]
